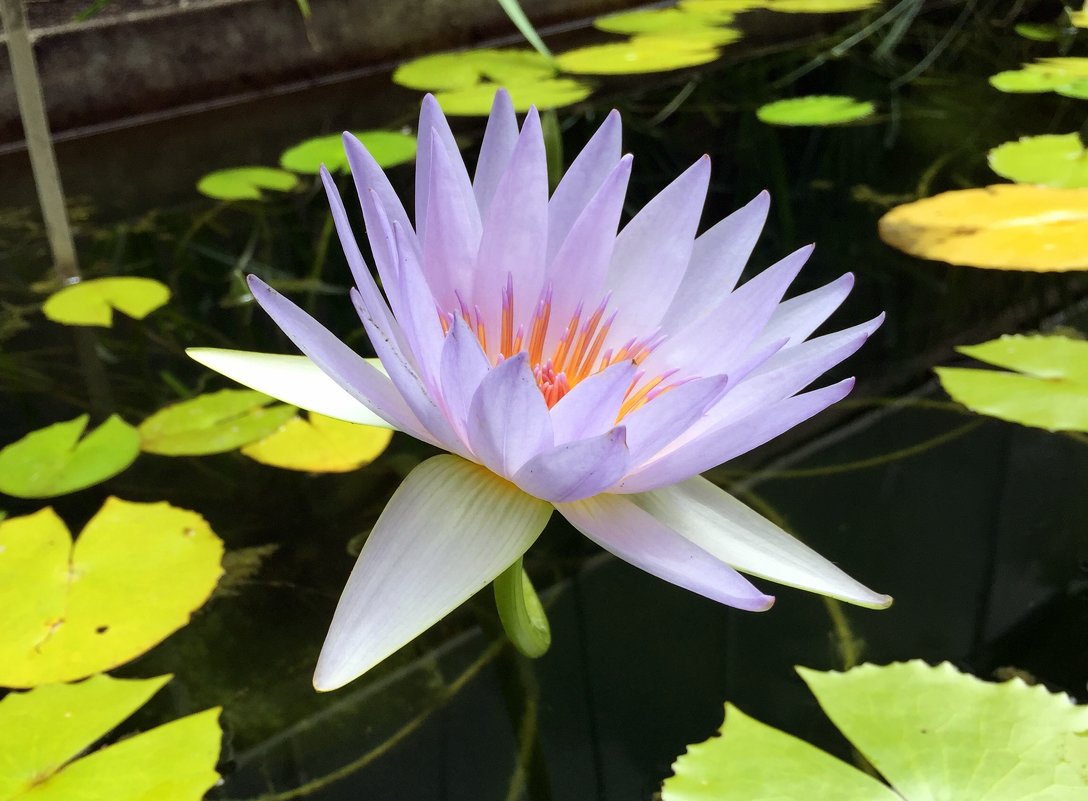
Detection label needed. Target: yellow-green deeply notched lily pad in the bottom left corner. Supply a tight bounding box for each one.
[0,676,220,801]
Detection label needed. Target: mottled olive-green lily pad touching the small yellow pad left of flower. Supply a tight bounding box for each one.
[138,390,295,456]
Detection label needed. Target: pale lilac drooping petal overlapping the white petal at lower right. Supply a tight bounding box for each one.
[556,495,775,612]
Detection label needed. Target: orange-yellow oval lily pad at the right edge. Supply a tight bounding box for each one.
[879,184,1088,272]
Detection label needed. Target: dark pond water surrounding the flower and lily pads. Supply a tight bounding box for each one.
[0,2,1088,801]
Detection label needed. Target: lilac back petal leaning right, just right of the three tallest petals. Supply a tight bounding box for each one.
[545,110,621,263]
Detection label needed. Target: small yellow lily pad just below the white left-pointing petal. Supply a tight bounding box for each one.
[242,411,393,472]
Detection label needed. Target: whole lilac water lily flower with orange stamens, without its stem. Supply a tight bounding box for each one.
[190,85,891,690]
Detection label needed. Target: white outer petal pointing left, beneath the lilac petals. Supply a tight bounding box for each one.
[185,347,394,429]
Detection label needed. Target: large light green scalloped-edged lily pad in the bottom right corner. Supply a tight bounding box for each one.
[662,661,1088,801]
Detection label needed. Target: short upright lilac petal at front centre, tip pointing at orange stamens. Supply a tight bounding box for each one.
[468,352,553,478]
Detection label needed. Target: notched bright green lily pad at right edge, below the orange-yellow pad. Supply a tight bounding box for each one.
[937,336,1088,431]
